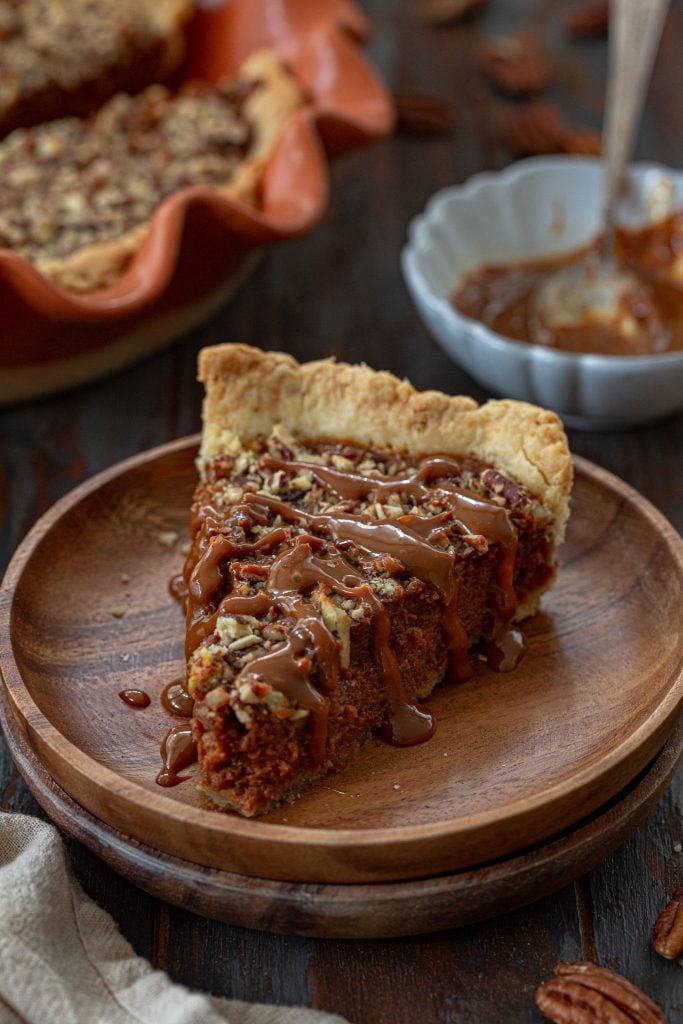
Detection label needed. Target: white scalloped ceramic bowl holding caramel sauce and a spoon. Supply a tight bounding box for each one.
[402,157,683,429]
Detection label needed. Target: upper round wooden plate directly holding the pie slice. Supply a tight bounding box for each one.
[0,438,683,883]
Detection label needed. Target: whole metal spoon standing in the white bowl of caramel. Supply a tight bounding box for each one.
[530,0,669,348]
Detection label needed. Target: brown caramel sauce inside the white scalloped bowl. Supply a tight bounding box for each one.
[451,210,683,355]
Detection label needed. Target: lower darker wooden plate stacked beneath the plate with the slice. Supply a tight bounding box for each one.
[0,687,683,939]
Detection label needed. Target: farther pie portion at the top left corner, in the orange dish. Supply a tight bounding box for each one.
[0,0,193,135]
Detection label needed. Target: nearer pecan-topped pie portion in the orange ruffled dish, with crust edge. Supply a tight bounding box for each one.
[0,50,302,292]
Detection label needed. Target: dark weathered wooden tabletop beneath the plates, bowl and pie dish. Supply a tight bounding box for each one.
[0,0,683,1024]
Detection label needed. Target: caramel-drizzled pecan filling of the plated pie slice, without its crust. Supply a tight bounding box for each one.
[159,430,554,815]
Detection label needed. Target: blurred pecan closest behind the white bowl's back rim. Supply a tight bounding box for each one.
[499,99,601,157]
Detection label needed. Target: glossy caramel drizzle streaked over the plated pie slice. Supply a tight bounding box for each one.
[179,455,517,764]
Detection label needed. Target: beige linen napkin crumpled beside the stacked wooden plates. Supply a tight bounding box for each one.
[0,812,344,1024]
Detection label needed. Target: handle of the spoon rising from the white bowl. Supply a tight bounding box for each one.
[602,0,669,261]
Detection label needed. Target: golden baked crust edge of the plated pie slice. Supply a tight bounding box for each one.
[199,344,573,618]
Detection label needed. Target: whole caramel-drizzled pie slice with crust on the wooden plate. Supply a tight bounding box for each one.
[171,345,572,815]
